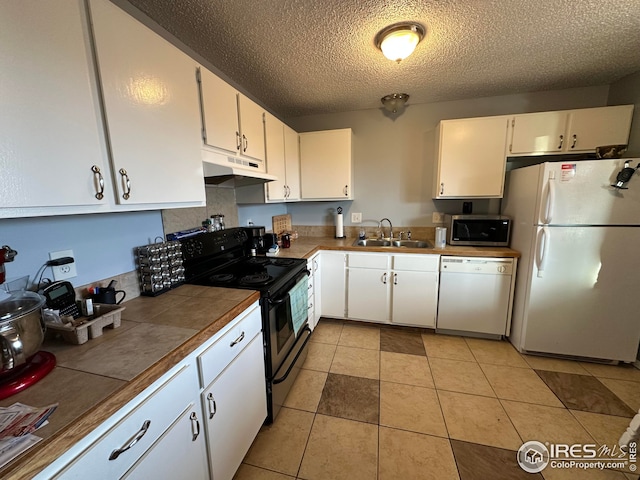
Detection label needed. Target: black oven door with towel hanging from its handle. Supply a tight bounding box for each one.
[266,270,309,376]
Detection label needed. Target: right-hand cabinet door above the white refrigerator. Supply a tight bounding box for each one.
[567,105,633,152]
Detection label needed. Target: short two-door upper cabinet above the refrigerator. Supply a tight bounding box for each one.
[508,105,633,155]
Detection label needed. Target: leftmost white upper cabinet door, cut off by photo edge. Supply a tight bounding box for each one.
[0,0,109,210]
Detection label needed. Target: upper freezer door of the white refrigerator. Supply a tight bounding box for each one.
[536,159,640,225]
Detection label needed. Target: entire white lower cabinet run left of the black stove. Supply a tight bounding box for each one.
[35,302,267,480]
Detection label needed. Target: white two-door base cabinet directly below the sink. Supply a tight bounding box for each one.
[347,252,439,328]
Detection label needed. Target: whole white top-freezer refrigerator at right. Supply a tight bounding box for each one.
[502,159,640,362]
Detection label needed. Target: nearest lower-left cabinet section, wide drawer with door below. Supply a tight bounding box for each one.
[48,359,208,480]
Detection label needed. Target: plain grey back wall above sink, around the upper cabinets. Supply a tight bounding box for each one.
[285,86,608,226]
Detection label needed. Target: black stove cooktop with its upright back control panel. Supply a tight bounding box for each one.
[181,229,307,295]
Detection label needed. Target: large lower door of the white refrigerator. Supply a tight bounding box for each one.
[516,227,640,362]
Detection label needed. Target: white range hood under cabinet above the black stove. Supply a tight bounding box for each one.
[202,155,278,187]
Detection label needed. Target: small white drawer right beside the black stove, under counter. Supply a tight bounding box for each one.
[198,305,262,387]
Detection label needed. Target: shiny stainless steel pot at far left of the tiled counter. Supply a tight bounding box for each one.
[0,291,45,374]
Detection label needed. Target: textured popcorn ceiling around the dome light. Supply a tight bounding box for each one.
[127,0,640,118]
